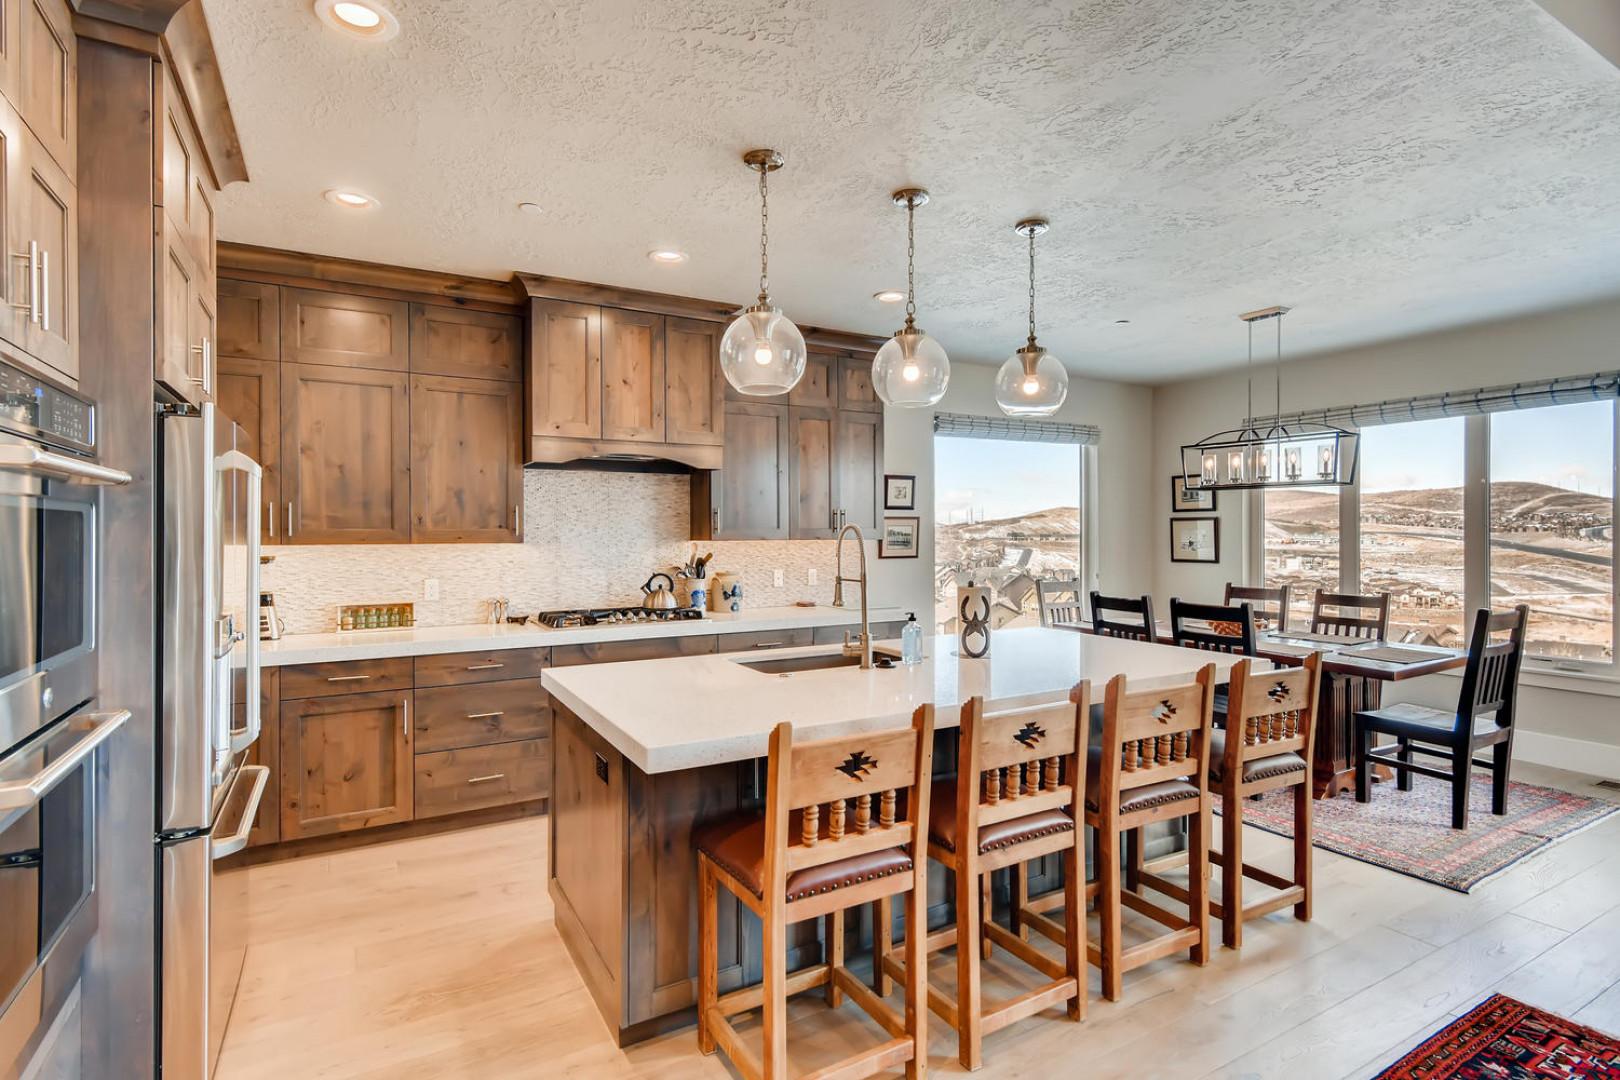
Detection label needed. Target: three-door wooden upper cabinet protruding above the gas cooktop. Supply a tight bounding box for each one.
[528,298,726,468]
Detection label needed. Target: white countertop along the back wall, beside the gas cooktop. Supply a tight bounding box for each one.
[259,606,906,667]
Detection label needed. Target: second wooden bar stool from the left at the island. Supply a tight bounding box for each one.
[878,682,1092,1069]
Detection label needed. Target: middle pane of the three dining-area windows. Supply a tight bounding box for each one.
[1358,416,1468,648]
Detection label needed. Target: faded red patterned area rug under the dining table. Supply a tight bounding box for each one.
[1215,774,1620,892]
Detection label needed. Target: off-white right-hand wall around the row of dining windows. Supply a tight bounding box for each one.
[1150,301,1620,764]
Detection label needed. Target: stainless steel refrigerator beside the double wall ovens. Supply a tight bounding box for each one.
[156,403,269,1080]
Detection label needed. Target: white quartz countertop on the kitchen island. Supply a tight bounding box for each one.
[541,627,1272,772]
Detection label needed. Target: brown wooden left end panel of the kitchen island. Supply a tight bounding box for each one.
[549,704,625,1033]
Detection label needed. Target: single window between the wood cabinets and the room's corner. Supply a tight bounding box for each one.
[933,436,1082,633]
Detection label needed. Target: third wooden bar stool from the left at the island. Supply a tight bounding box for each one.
[1085,664,1215,1001]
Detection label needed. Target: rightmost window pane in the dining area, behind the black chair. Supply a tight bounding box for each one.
[1490,402,1615,664]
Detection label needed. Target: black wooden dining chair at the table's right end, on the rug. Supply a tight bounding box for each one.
[1354,604,1529,829]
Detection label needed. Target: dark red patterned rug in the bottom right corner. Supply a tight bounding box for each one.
[1375,994,1620,1080]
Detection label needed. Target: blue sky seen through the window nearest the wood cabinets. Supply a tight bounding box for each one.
[933,437,1081,521]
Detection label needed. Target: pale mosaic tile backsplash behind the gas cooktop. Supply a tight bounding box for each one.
[264,470,876,633]
